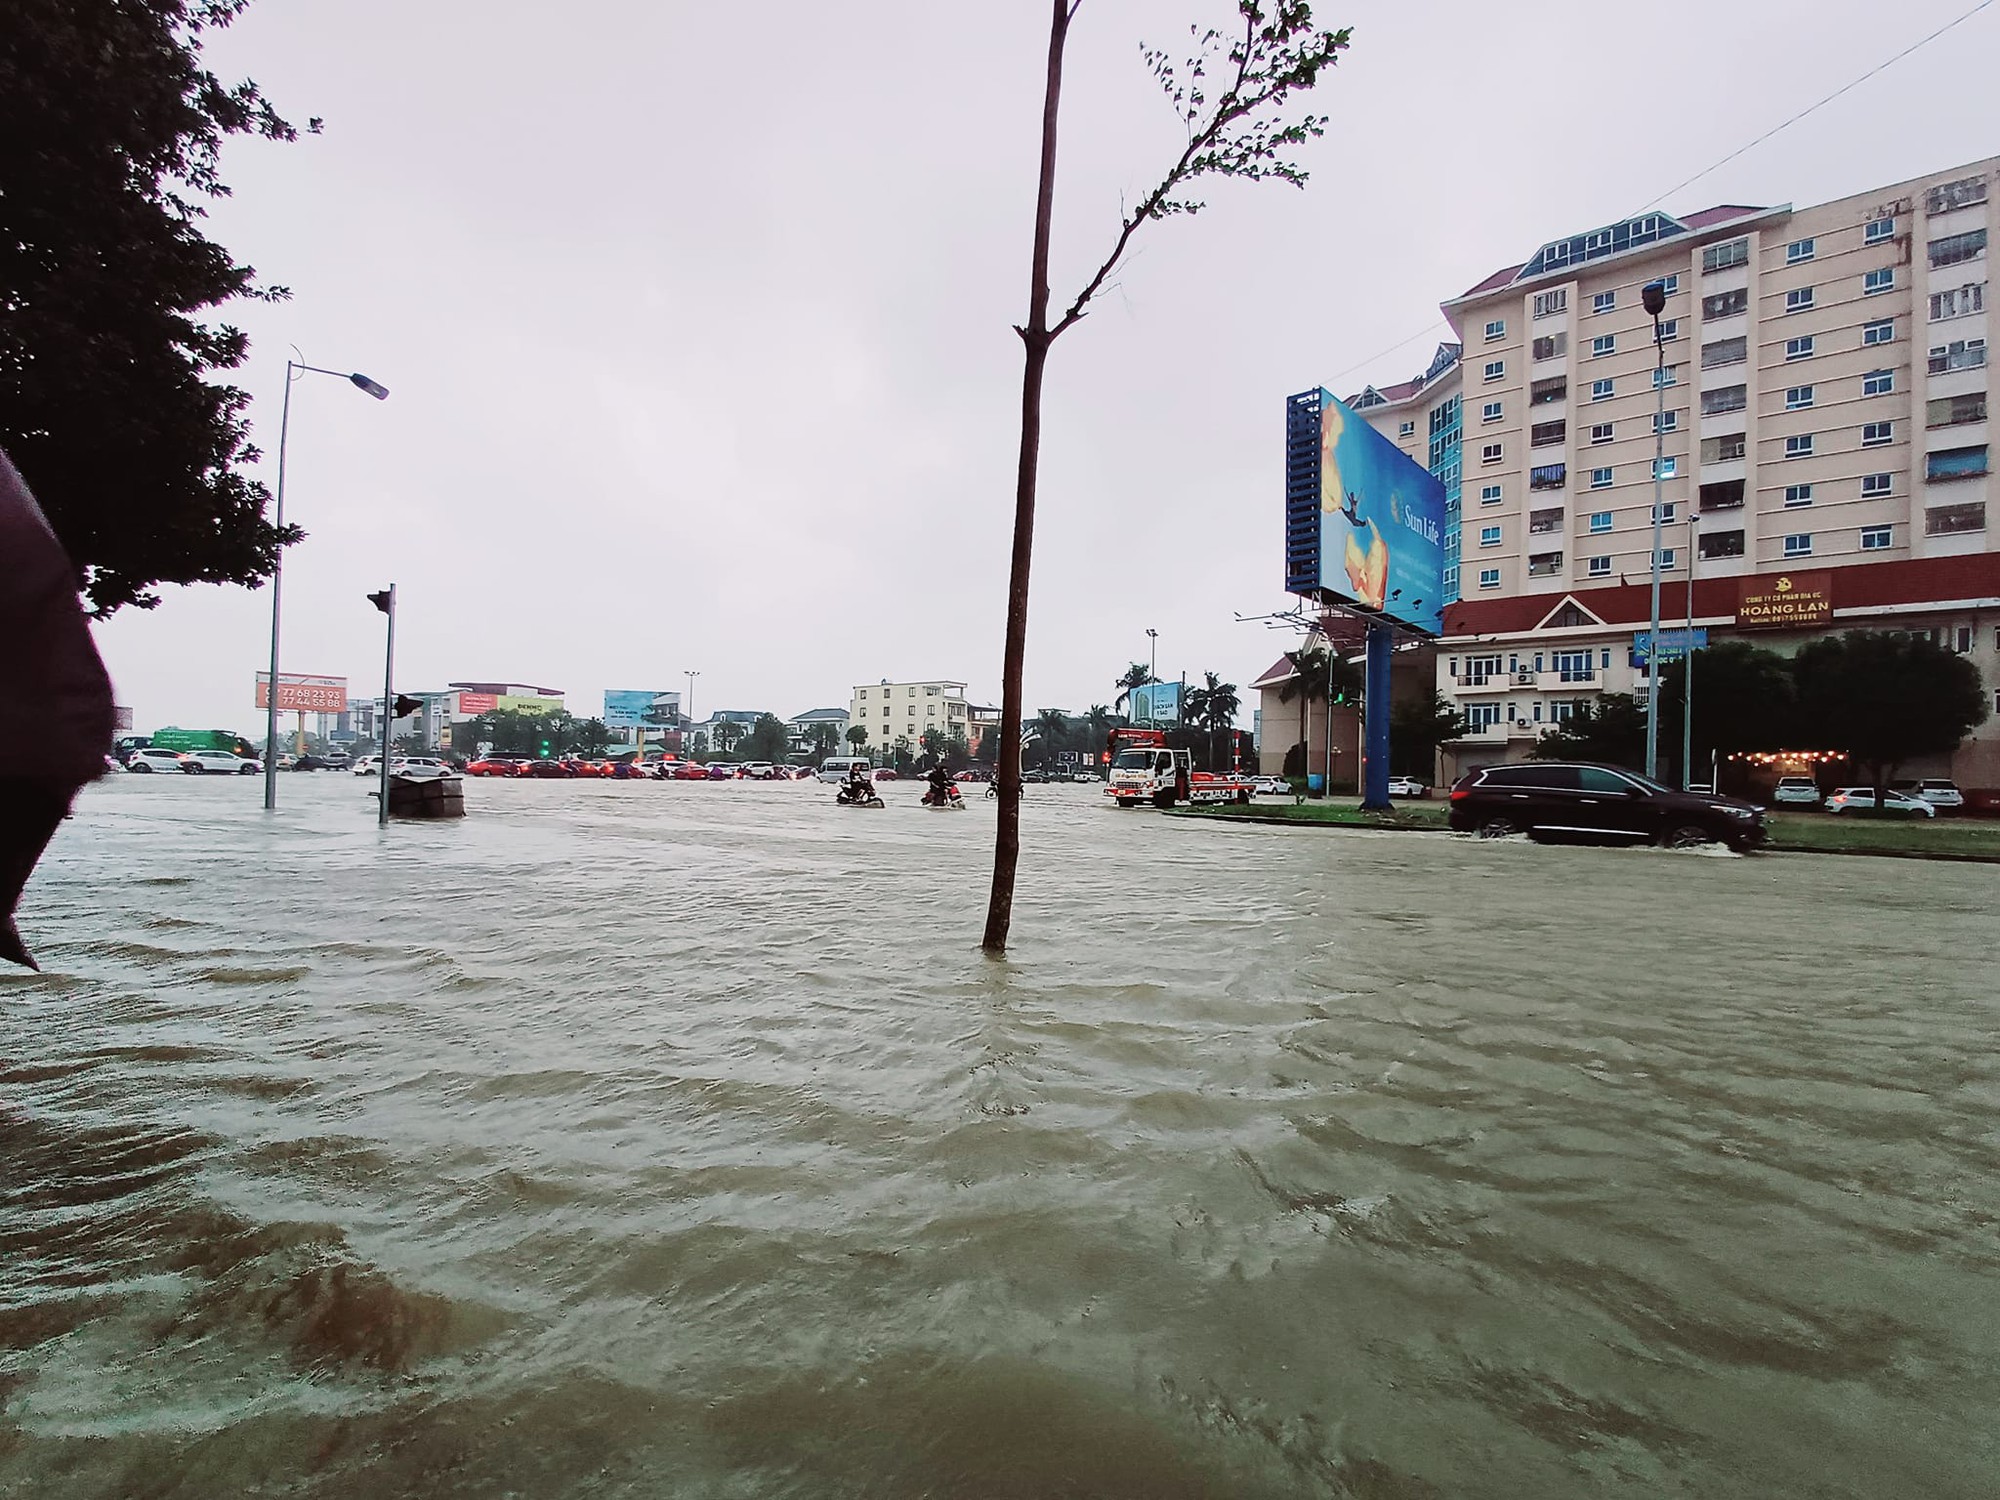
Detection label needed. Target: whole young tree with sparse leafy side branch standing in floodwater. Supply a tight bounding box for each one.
[980,0,1348,954]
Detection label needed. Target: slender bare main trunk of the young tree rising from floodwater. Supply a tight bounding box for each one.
[980,0,1074,954]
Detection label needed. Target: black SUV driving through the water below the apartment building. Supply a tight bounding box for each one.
[1450,760,1764,850]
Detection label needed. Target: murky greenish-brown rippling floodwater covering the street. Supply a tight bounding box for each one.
[0,774,2000,1500]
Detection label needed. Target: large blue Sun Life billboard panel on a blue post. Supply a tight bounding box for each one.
[1284,390,1444,636]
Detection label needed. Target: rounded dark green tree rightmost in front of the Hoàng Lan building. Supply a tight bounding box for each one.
[1792,630,1986,804]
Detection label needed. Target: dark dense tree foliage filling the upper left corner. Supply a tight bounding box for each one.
[0,0,318,614]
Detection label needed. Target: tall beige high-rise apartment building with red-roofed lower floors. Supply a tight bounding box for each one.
[1350,158,2000,788]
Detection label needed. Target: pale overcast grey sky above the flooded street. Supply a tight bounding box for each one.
[100,0,2000,734]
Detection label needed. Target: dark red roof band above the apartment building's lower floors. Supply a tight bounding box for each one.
[1444,552,2000,636]
